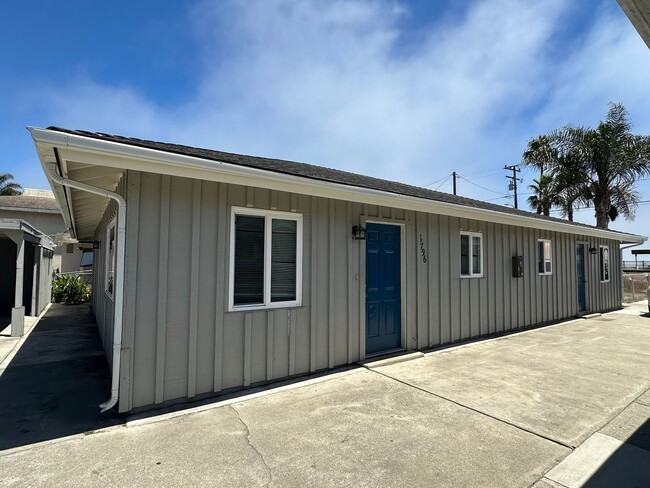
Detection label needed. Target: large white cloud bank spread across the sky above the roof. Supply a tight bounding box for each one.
[20,0,650,243]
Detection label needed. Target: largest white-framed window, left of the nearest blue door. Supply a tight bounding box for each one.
[229,207,302,311]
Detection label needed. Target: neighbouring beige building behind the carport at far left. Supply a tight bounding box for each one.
[0,188,83,273]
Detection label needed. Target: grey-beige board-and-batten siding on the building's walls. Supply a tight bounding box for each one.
[106,171,621,411]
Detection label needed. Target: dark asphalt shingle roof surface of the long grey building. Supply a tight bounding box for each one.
[48,127,631,235]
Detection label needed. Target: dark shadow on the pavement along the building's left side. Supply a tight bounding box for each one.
[0,303,123,450]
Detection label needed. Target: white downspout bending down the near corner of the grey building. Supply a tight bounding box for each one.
[48,163,126,412]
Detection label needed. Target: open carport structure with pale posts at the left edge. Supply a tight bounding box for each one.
[0,219,54,337]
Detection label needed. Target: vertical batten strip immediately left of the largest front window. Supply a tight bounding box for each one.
[213,183,229,391]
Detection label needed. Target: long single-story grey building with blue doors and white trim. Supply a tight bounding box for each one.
[29,127,646,412]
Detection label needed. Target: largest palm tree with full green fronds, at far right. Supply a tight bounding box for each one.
[558,103,650,229]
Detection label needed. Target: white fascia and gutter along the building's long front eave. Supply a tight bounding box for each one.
[30,128,647,244]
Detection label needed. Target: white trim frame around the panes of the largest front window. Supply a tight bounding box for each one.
[228,207,303,312]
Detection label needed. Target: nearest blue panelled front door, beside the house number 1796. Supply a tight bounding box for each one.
[366,224,402,354]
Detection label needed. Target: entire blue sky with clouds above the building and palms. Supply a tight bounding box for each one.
[0,0,650,250]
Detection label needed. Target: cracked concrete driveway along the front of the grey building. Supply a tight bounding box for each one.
[0,302,650,488]
